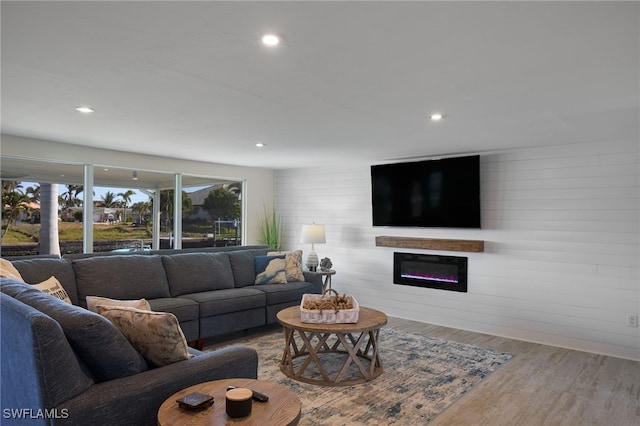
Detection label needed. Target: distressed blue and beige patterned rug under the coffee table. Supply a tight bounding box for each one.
[218,328,512,426]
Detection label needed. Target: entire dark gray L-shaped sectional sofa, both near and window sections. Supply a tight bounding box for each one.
[0,247,322,426]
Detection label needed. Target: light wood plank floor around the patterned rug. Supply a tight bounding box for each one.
[207,317,640,426]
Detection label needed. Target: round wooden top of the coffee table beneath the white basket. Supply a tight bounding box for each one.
[277,306,387,334]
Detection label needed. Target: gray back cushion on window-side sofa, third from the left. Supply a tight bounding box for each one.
[162,253,233,297]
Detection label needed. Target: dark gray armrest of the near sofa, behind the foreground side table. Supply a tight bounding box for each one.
[54,346,258,426]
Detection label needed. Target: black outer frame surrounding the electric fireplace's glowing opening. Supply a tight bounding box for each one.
[393,252,468,293]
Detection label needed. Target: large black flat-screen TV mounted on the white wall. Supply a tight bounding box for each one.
[371,155,480,228]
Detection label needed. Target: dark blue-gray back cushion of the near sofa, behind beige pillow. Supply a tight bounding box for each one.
[16,284,147,381]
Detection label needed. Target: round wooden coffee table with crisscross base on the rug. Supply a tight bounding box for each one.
[277,306,387,386]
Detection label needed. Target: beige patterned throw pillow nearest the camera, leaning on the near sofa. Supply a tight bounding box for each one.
[97,305,193,366]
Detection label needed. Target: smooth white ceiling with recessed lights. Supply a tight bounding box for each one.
[1,1,640,168]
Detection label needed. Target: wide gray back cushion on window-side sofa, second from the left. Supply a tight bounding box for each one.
[72,254,171,306]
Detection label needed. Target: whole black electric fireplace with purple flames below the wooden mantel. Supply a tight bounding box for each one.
[393,252,467,293]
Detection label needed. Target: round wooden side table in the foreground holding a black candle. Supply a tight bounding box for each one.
[158,379,302,426]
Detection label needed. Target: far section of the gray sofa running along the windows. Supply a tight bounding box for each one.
[12,246,322,349]
